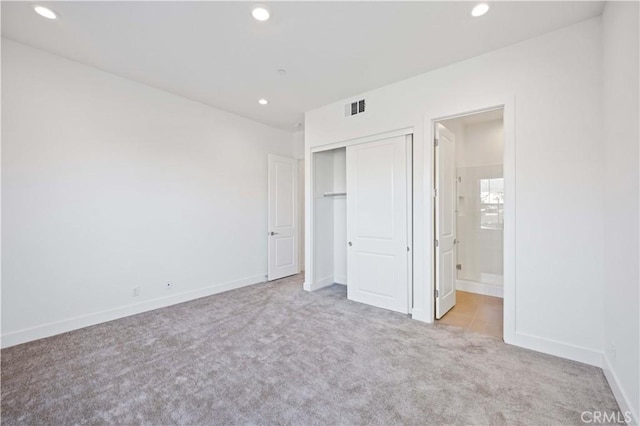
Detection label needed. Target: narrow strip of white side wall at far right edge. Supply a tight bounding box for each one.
[603,2,640,424]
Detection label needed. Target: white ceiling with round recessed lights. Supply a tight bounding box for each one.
[2,1,603,131]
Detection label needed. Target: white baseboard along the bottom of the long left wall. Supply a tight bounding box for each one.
[0,274,265,348]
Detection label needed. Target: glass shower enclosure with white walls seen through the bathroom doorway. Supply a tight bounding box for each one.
[441,109,505,297]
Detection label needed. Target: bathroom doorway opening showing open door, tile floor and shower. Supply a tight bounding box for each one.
[433,108,505,338]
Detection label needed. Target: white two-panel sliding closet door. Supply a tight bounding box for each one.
[347,136,409,313]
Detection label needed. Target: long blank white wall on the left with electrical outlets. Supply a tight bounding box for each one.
[2,39,293,346]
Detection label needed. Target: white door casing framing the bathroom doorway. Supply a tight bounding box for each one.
[422,95,517,344]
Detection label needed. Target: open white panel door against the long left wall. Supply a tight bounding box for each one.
[268,155,298,281]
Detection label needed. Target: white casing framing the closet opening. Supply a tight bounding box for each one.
[303,127,416,313]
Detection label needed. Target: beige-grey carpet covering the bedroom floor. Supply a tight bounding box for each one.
[1,276,618,425]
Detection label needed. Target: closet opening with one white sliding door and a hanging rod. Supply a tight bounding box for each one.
[305,129,413,314]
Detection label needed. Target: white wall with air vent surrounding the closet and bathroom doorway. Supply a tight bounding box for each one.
[305,18,604,364]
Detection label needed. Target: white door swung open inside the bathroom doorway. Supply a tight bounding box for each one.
[435,123,458,319]
